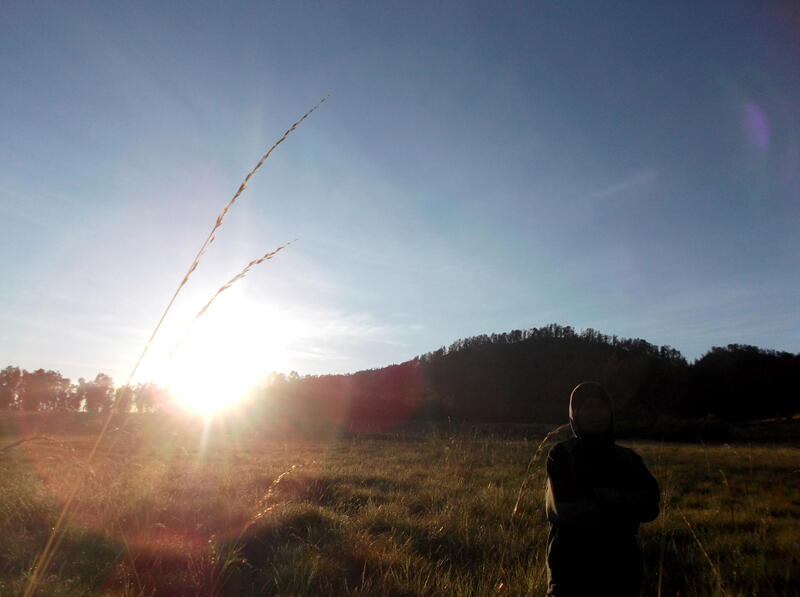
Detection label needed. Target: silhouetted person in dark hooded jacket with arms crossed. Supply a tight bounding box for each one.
[545,381,660,597]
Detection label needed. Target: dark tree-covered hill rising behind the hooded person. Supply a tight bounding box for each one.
[268,324,800,427]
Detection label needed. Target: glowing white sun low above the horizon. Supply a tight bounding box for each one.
[162,292,290,416]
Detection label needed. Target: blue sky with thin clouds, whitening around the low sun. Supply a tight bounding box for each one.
[0,1,800,383]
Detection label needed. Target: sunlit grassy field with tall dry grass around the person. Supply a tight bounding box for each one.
[0,416,800,596]
